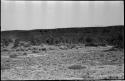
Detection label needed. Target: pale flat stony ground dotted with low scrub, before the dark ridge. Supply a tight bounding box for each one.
[1,46,124,80]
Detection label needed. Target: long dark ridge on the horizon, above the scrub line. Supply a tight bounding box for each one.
[1,25,124,48]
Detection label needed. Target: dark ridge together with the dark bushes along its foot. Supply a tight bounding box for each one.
[1,25,124,49]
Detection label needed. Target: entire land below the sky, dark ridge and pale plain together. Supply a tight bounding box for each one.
[1,26,124,81]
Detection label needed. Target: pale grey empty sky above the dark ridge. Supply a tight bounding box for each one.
[1,0,124,31]
